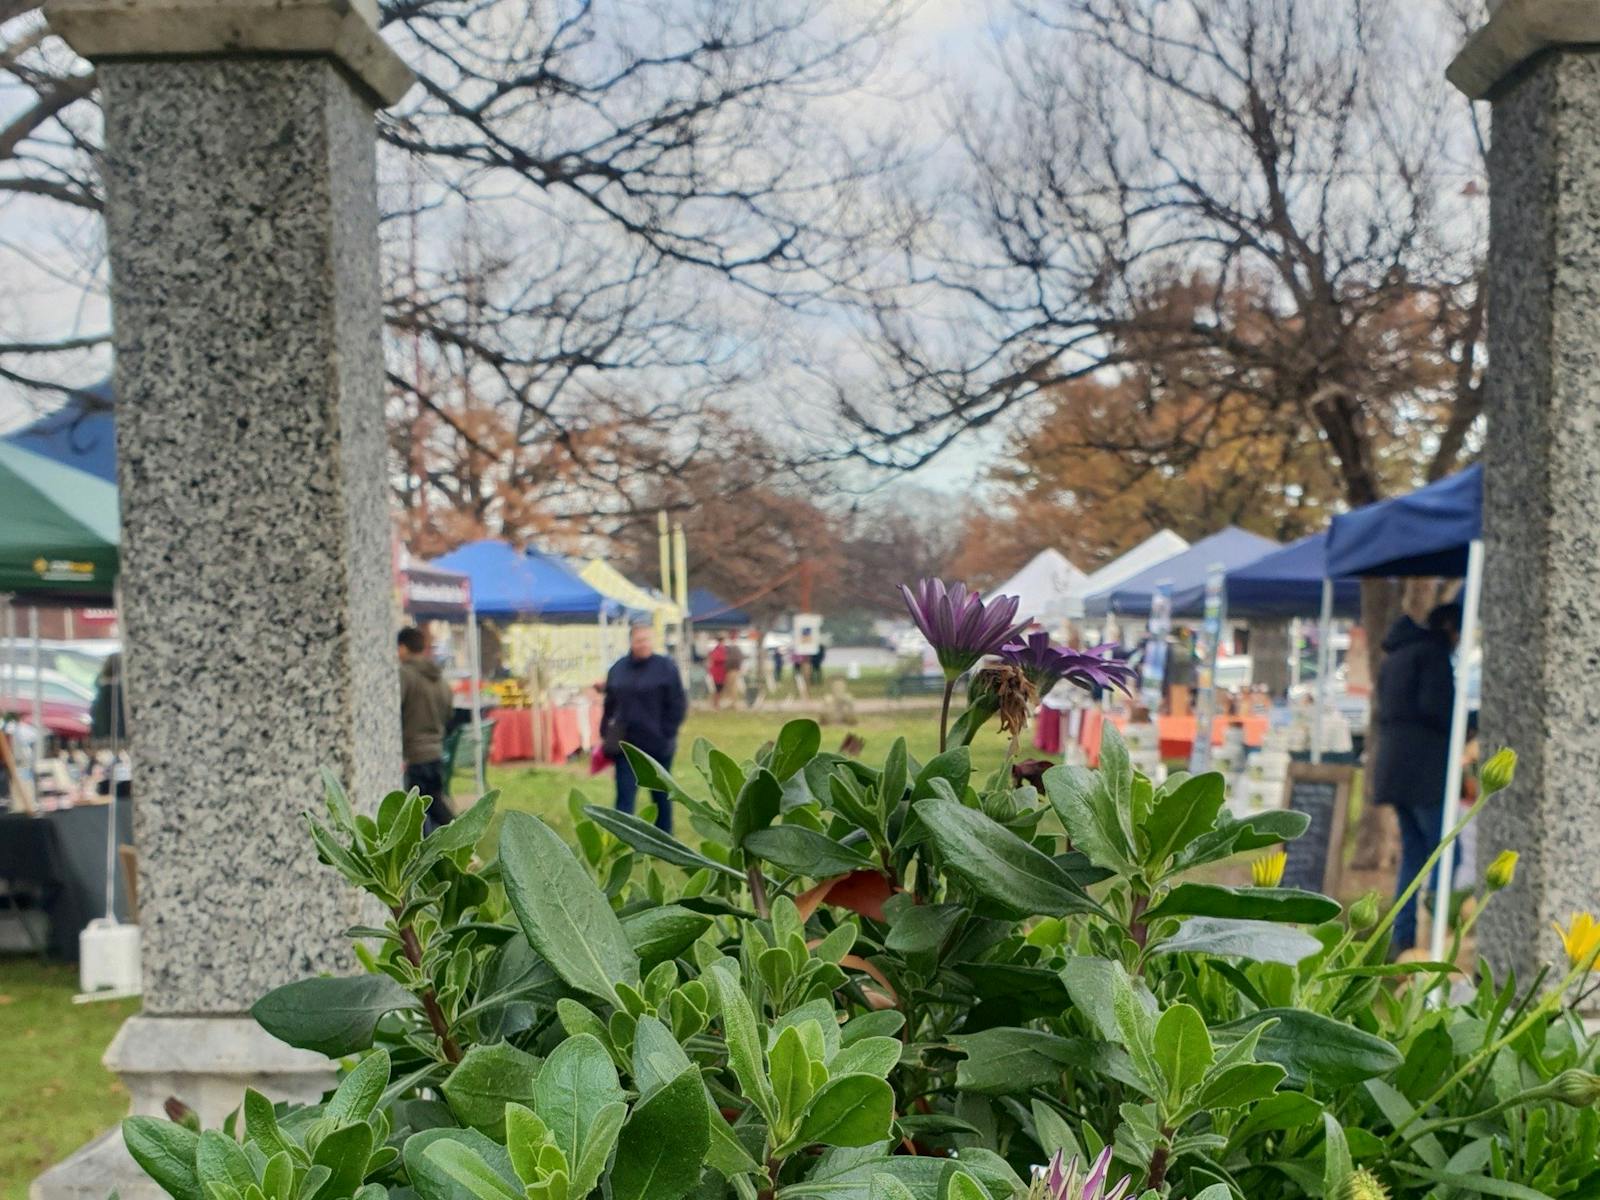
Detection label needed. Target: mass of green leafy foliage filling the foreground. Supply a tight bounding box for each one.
[125,720,1600,1200]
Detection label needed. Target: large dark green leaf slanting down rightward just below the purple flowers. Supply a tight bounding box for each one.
[917,798,1106,917]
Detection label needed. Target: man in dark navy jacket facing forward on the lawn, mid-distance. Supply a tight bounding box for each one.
[600,626,690,834]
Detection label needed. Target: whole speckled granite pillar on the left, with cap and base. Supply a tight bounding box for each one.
[34,0,410,1200]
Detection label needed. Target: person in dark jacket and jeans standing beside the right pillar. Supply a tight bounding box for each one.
[1371,605,1461,952]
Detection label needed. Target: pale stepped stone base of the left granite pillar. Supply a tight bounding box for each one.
[29,1016,334,1200]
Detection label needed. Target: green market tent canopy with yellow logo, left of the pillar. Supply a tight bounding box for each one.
[0,442,118,600]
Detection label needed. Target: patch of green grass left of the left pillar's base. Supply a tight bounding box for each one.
[0,958,139,1200]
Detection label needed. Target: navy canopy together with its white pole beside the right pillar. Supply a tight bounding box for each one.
[1328,466,1483,960]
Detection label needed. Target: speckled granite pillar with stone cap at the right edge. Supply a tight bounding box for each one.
[1450,0,1600,979]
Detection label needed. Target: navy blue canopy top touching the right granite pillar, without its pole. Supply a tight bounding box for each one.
[1328,466,1483,578]
